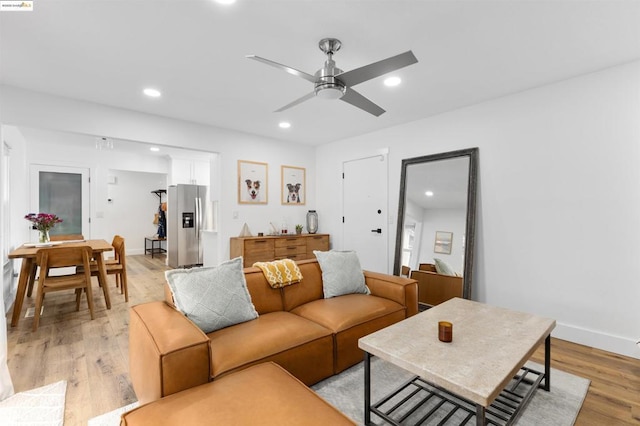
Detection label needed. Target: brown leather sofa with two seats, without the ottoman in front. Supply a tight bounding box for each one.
[129,259,418,404]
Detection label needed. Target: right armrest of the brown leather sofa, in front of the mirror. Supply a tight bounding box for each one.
[364,271,418,317]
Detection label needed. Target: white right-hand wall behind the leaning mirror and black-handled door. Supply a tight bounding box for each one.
[316,62,640,357]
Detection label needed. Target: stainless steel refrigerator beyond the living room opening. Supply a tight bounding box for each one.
[167,185,208,268]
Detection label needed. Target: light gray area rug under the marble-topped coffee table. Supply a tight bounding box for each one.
[88,358,590,426]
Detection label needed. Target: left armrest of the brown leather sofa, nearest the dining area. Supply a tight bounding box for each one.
[129,301,210,404]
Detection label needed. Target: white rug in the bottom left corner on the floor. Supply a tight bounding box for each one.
[0,380,67,426]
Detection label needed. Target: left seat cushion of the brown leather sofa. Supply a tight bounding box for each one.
[208,312,333,384]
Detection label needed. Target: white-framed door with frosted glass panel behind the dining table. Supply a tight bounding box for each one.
[30,164,91,241]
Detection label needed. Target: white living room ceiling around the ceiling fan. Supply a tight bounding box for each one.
[0,0,640,144]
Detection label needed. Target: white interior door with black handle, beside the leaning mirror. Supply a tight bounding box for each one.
[342,155,389,273]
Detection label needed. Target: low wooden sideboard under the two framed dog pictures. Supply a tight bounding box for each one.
[230,234,329,268]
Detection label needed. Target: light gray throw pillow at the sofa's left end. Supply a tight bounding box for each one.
[165,257,258,333]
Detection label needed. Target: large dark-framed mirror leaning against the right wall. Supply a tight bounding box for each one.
[394,148,478,306]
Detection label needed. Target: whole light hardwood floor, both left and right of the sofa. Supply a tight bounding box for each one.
[7,255,640,426]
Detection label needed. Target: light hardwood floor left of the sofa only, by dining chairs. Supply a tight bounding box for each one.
[6,255,168,426]
